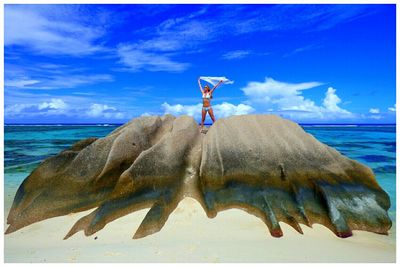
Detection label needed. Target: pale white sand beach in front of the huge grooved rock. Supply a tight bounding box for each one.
[4,198,396,263]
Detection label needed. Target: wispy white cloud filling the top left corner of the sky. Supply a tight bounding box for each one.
[4,5,104,56]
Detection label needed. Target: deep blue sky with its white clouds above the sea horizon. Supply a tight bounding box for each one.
[4,4,396,123]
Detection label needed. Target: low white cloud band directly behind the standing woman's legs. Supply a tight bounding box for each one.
[161,102,255,119]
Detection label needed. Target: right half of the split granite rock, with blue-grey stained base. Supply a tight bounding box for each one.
[200,115,391,237]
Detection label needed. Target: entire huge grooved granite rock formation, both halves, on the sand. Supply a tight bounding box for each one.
[6,115,391,238]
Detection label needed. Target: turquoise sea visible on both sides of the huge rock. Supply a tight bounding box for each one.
[4,125,396,223]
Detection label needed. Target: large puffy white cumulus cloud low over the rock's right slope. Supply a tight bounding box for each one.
[242,77,353,119]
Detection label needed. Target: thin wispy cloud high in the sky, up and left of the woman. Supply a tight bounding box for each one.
[117,8,214,72]
